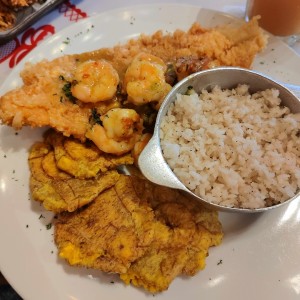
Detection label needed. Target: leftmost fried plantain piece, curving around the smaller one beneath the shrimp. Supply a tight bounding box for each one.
[29,132,119,213]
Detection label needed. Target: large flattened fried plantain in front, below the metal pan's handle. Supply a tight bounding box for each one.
[55,175,223,293]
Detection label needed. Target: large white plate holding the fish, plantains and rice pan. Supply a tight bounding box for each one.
[0,5,300,300]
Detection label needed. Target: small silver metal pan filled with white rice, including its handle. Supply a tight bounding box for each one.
[138,67,300,212]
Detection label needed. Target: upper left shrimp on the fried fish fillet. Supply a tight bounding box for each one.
[71,59,119,103]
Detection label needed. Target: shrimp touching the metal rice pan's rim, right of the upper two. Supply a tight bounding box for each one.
[124,53,171,105]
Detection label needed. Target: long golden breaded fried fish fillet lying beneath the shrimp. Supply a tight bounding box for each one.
[0,19,266,141]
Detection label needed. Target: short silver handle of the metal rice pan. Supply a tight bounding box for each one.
[138,135,187,191]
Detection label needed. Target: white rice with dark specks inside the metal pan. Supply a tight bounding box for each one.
[160,85,300,208]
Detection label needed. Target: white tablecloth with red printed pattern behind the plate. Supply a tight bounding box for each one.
[0,0,300,300]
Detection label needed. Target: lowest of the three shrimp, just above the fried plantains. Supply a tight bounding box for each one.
[86,108,143,155]
